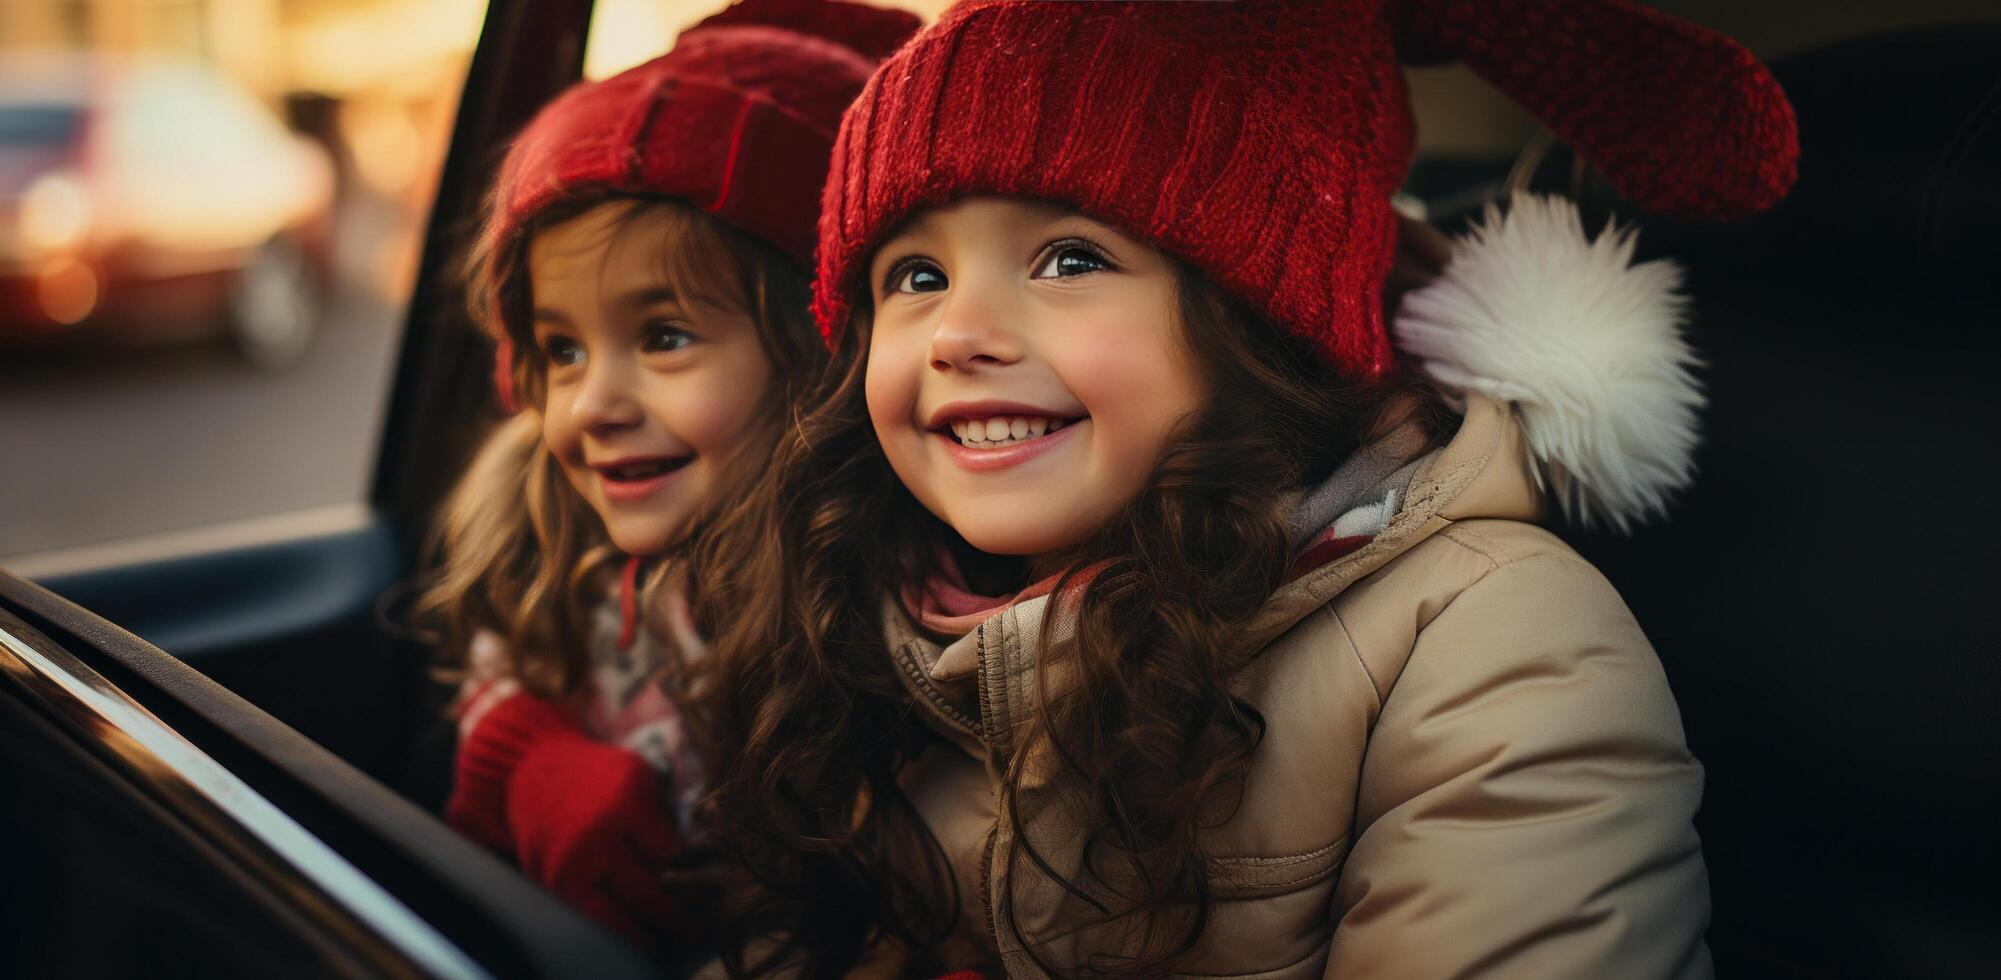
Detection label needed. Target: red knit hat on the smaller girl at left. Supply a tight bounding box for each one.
[482,0,918,408]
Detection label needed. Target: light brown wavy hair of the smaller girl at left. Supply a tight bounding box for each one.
[412,190,826,694]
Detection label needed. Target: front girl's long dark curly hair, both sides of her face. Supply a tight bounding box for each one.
[692,253,1457,976]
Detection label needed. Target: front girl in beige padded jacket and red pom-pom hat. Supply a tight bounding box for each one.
[696,0,1797,978]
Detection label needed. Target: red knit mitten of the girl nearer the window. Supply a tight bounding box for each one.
[444,694,688,946]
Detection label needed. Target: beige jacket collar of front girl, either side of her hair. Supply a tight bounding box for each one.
[882,392,1545,766]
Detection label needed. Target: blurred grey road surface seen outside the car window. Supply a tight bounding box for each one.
[0,292,400,554]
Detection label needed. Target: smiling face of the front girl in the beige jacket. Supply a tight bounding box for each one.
[866,198,1207,556]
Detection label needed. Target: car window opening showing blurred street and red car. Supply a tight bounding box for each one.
[0,0,484,568]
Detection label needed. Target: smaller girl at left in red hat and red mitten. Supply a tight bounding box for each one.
[422,0,916,944]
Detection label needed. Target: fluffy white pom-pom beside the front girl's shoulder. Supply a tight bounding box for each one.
[1395,194,1705,532]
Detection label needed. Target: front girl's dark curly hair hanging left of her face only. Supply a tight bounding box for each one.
[682,304,956,976]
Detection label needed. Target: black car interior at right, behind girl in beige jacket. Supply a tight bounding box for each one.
[1571,24,2001,976]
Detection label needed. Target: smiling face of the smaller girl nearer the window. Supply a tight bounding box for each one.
[528,202,770,554]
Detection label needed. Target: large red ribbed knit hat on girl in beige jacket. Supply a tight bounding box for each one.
[814,0,1799,380]
